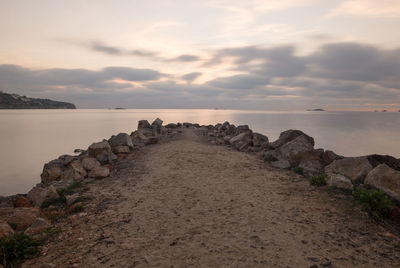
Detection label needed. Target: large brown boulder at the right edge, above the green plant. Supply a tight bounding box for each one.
[364,164,400,202]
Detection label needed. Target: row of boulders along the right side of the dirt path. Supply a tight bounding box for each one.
[202,122,400,202]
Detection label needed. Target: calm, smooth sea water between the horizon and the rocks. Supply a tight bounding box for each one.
[0,109,400,195]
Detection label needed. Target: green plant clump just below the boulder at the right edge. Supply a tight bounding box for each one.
[353,187,394,215]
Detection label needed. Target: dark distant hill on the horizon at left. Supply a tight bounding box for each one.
[0,91,76,109]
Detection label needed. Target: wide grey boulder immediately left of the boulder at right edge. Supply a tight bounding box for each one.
[325,156,372,183]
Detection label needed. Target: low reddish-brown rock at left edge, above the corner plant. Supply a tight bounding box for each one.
[0,208,40,231]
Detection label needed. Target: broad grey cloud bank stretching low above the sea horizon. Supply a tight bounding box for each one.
[0,43,400,109]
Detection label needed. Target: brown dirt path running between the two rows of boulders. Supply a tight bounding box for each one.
[22,131,400,267]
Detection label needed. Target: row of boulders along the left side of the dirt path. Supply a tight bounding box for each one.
[0,118,182,237]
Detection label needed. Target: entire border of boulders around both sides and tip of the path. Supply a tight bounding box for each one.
[0,118,400,237]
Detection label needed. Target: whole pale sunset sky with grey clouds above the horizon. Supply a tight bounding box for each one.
[0,0,400,111]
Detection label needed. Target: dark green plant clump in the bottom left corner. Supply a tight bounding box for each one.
[0,232,40,267]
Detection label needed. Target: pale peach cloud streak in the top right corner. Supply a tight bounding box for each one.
[328,0,400,18]
